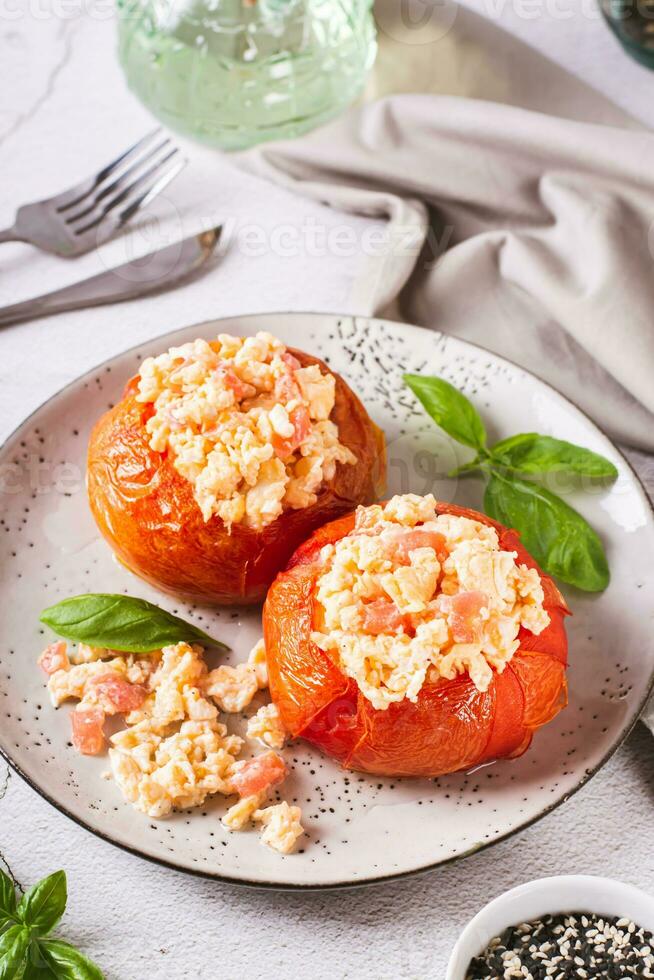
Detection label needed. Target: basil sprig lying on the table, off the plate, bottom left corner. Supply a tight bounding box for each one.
[0,870,104,980]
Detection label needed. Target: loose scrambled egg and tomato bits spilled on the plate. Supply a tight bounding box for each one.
[40,641,304,854]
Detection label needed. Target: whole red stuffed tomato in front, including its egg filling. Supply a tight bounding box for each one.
[263,495,568,776]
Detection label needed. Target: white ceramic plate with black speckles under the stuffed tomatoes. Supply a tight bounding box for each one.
[0,314,654,888]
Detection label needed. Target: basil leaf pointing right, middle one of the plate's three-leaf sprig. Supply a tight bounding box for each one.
[490,432,618,480]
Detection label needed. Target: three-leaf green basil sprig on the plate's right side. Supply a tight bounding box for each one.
[404,374,618,592]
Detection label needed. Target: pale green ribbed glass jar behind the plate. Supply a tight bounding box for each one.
[117,0,376,150]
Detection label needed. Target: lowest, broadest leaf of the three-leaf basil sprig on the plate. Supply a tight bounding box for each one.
[484,473,610,592]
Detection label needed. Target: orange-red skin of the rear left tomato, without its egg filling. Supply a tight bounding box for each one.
[87,350,386,605]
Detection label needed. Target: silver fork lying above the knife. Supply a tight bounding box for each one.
[0,129,186,258]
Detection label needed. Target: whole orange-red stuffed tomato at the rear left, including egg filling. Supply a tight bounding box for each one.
[88,333,385,604]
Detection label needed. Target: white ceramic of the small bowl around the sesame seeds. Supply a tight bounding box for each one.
[445,875,654,980]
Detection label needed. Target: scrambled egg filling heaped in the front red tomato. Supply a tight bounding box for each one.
[312,494,549,710]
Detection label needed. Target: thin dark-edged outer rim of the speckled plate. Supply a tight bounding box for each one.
[0,310,654,892]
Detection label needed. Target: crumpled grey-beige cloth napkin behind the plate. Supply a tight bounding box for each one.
[241,94,654,451]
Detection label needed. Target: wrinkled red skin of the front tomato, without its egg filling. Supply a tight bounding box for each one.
[263,503,568,776]
